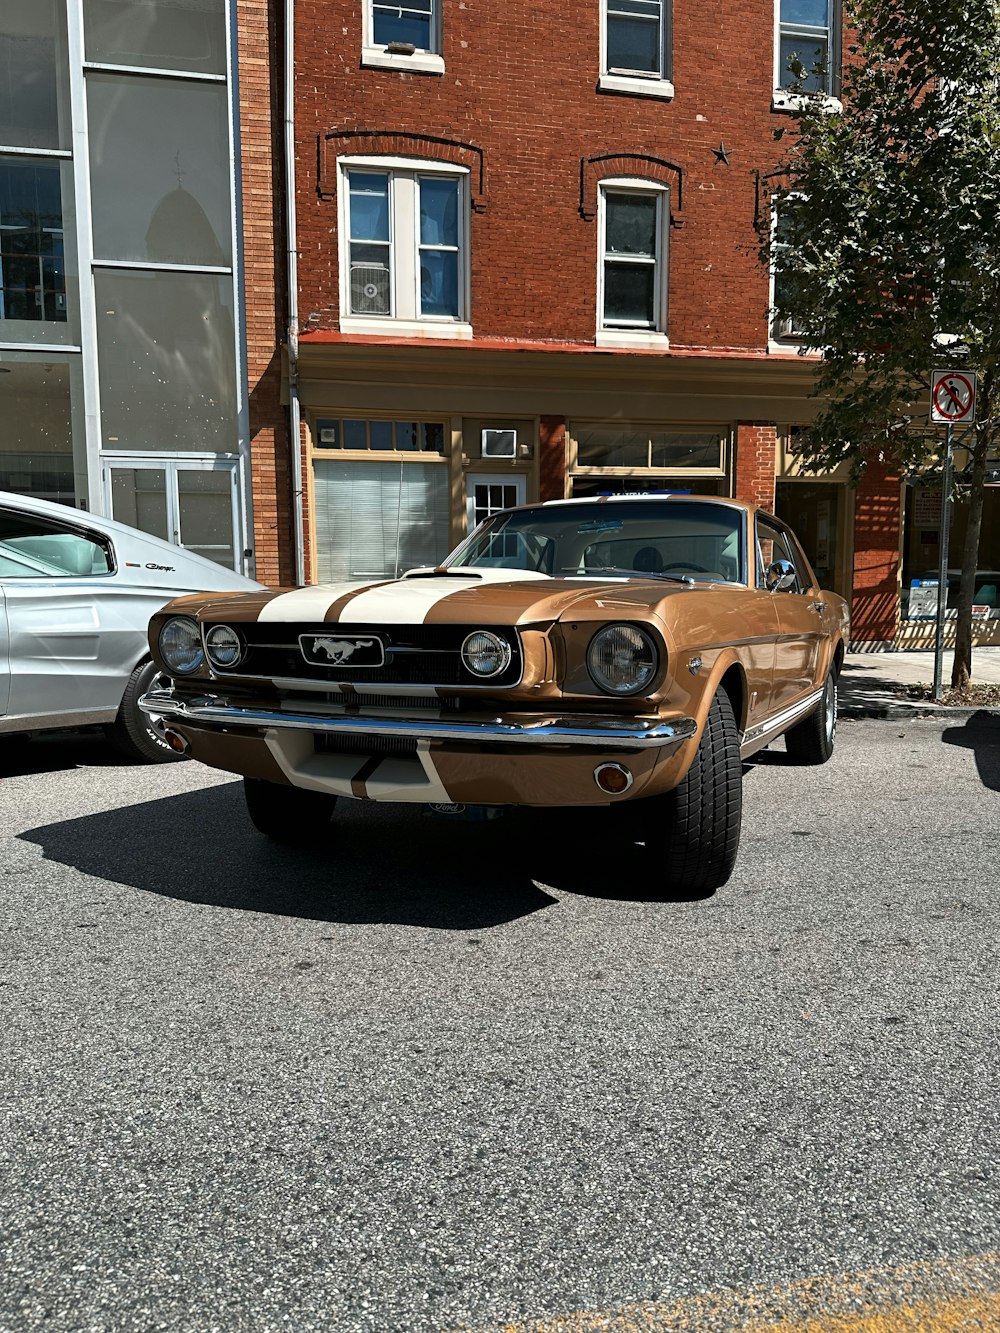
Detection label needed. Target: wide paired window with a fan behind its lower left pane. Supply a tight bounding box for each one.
[341,165,468,335]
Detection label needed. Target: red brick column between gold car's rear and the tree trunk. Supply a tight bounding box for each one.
[851,461,903,651]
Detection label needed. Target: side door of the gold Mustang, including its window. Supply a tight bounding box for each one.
[756,513,825,710]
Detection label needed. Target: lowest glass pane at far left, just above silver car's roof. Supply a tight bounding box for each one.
[0,357,75,505]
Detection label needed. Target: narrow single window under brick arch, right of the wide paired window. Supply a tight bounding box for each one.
[599,181,668,335]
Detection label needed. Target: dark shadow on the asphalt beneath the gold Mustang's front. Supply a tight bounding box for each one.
[20,782,720,930]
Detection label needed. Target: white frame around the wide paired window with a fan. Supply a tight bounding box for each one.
[337,156,472,339]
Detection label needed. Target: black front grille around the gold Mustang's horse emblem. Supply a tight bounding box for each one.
[205,621,521,689]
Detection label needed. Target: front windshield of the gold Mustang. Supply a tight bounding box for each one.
[445,500,745,583]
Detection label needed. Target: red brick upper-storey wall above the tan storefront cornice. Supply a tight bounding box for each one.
[289,0,787,349]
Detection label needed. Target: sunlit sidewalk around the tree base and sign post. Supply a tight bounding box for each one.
[837,648,1000,717]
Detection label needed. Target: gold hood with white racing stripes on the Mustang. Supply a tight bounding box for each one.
[169,569,691,625]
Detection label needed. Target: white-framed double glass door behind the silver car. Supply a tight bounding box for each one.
[103,455,243,572]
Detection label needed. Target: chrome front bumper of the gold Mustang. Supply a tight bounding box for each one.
[139,690,697,750]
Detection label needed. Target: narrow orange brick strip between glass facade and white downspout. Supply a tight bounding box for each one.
[239,0,295,584]
